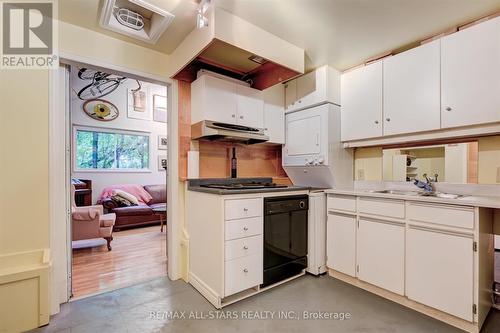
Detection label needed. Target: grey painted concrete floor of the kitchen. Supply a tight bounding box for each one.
[32,276,500,333]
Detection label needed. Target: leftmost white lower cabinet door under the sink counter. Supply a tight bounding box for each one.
[326,213,356,276]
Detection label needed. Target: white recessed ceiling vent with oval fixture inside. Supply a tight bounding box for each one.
[100,0,174,44]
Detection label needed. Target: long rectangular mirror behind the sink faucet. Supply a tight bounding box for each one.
[382,141,478,184]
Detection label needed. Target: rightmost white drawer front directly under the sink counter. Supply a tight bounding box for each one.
[408,202,474,229]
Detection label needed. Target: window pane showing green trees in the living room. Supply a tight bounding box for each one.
[75,129,149,170]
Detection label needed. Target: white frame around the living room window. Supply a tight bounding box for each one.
[71,125,153,173]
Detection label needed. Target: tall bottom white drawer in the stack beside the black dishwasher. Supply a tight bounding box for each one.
[224,253,263,296]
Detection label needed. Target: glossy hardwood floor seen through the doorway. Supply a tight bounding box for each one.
[73,226,167,298]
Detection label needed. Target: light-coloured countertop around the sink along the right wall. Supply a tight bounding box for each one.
[325,189,500,209]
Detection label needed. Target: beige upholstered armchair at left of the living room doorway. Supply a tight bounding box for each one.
[71,185,116,251]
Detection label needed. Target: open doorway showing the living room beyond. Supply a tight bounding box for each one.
[66,63,172,299]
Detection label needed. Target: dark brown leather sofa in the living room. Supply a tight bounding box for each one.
[99,185,167,231]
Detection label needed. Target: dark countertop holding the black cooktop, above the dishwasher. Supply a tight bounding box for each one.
[188,178,311,195]
